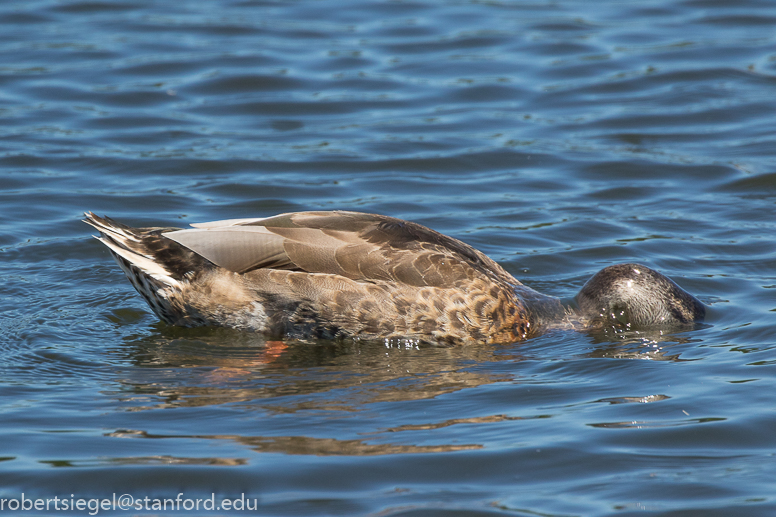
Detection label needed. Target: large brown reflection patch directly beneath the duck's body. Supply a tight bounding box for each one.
[112,327,520,412]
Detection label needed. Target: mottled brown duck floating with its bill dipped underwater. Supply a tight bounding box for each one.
[83,211,706,344]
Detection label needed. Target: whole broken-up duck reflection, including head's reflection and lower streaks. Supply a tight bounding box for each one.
[87,323,707,464]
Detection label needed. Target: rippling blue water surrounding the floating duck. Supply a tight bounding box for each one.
[0,0,776,516]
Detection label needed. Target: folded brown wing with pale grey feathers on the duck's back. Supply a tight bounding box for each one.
[163,212,519,287]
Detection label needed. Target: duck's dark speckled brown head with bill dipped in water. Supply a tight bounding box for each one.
[575,264,706,328]
